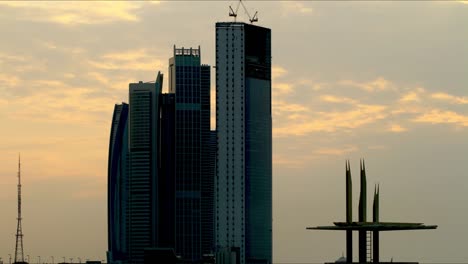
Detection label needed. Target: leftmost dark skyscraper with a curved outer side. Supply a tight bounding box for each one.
[107,103,128,263]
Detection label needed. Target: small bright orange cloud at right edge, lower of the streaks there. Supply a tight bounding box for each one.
[413,109,468,127]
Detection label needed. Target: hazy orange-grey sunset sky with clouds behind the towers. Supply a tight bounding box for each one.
[0,1,468,263]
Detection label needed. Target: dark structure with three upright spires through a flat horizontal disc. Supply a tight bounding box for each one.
[306,160,437,264]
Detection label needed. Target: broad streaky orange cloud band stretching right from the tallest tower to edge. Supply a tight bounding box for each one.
[272,74,468,138]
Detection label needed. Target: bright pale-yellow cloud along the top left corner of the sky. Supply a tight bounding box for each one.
[0,1,144,25]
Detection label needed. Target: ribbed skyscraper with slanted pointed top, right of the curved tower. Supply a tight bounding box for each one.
[128,73,163,263]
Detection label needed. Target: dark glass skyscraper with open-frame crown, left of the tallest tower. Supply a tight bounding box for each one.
[169,46,214,261]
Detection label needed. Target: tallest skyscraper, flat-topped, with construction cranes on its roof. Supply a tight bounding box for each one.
[215,22,272,264]
